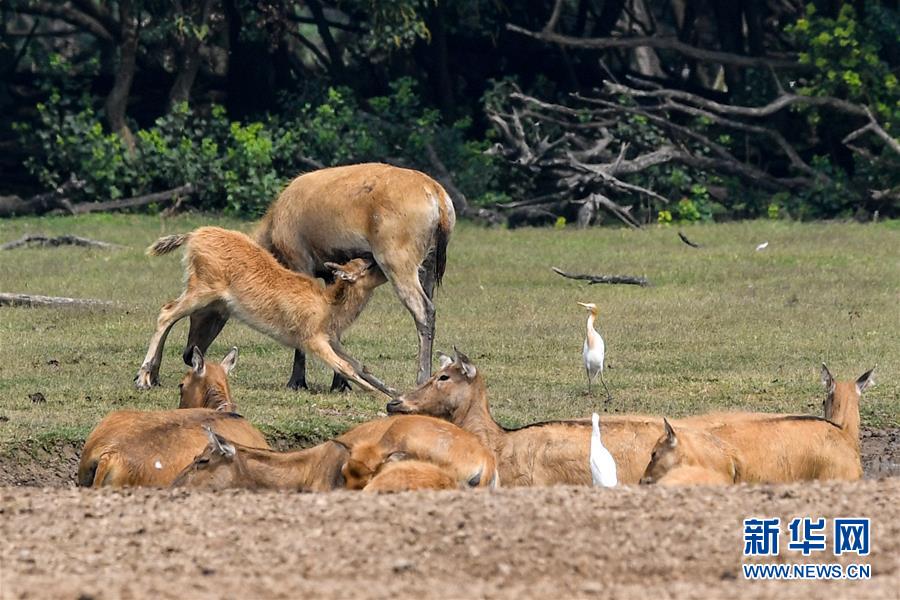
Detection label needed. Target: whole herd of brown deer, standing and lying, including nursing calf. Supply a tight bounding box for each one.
[78,164,873,492]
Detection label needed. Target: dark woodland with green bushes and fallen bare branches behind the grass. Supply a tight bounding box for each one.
[0,0,900,223]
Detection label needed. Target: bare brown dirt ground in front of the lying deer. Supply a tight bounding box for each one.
[0,478,900,599]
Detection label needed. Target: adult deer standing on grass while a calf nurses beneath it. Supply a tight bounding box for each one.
[184,163,456,390]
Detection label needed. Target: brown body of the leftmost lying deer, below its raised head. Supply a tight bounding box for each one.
[78,408,268,487]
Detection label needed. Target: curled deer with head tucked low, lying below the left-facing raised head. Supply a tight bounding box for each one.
[339,415,497,490]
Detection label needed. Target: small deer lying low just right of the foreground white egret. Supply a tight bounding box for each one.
[641,419,742,485]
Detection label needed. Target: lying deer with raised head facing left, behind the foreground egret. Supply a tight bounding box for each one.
[387,352,663,486]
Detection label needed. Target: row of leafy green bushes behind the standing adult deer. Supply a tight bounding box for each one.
[17,79,506,216]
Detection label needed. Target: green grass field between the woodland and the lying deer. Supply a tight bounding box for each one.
[0,215,900,453]
